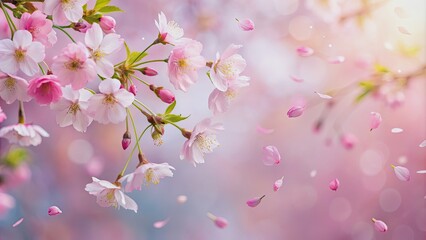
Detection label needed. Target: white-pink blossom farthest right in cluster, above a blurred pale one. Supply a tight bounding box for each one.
[210,44,247,92]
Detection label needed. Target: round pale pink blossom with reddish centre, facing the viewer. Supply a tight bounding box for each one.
[52,43,97,90]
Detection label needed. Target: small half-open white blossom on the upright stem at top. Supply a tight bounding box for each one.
[155,12,183,44]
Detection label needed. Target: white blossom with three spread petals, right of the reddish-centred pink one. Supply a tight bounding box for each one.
[84,23,124,78]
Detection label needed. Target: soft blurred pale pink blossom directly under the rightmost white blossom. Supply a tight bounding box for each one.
[208,76,250,115]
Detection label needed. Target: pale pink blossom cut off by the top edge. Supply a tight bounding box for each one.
[44,0,88,25]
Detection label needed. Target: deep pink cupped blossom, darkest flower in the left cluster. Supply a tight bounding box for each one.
[27,75,62,104]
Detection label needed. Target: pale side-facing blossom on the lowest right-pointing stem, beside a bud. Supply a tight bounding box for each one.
[180,118,223,166]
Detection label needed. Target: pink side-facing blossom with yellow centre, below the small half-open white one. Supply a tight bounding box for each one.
[168,38,206,91]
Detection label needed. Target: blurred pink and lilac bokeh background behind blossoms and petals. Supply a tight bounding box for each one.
[0,0,426,240]
